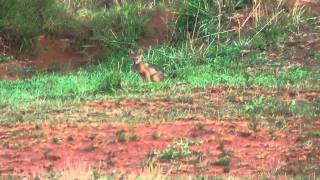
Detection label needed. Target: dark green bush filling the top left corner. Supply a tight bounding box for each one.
[0,0,55,50]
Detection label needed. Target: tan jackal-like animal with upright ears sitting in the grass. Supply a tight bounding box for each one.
[129,49,163,82]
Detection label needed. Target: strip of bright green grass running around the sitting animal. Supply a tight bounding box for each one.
[0,43,320,105]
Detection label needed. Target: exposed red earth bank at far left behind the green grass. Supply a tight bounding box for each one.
[0,36,91,80]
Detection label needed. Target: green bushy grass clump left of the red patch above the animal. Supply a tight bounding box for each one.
[91,3,151,49]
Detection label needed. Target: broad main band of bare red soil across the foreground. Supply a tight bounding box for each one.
[0,119,310,175]
